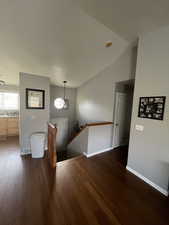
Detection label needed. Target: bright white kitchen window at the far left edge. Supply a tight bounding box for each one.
[0,92,19,110]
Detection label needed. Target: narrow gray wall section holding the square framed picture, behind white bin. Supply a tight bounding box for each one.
[20,73,50,154]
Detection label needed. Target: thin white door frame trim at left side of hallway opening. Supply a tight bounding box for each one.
[112,92,126,148]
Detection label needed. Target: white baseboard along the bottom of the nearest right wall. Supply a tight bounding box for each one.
[126,166,169,196]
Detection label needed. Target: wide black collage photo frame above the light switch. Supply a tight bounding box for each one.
[138,96,166,120]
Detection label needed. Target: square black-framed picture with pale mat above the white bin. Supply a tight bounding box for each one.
[26,88,45,109]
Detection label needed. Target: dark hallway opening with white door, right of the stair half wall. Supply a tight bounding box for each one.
[113,80,134,164]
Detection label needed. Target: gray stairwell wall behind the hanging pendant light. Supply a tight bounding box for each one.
[50,85,76,135]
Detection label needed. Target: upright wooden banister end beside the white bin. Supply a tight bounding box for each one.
[47,123,57,168]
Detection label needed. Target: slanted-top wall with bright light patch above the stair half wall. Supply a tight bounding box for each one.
[77,47,135,124]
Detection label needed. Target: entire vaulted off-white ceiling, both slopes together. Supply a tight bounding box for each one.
[0,0,169,87]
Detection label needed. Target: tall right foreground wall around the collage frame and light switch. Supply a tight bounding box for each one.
[128,27,169,190]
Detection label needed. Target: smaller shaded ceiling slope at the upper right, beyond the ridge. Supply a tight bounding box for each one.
[74,0,169,41]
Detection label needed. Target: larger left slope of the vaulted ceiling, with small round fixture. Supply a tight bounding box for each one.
[0,0,127,87]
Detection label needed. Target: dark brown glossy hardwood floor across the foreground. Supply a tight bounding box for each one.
[0,138,169,225]
